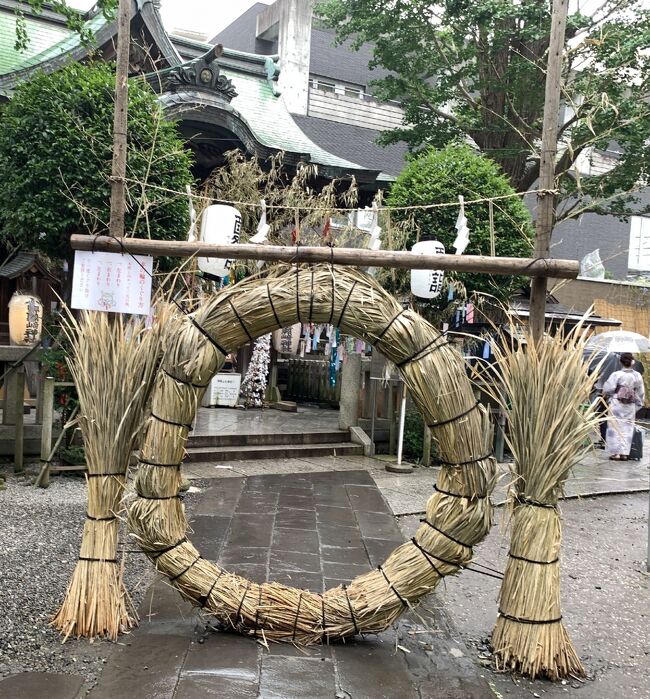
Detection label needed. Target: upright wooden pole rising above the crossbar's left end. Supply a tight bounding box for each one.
[109,0,131,238]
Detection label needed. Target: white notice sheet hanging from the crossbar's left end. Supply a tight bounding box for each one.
[70,250,153,315]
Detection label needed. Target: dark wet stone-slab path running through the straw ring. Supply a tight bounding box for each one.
[90,470,493,699]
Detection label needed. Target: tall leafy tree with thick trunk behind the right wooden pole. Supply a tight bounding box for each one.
[318,0,650,217]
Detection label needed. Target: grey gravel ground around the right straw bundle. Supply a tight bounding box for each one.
[401,493,650,699]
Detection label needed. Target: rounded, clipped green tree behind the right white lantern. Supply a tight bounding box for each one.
[382,143,532,304]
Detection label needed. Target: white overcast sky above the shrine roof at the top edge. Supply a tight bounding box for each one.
[68,0,272,39]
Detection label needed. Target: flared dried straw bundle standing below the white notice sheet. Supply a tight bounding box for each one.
[52,309,166,640]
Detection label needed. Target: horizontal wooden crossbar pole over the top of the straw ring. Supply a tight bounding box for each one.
[70,234,580,279]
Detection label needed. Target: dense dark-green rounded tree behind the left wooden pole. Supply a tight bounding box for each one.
[0,63,192,258]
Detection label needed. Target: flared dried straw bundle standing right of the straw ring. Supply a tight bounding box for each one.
[478,326,598,680]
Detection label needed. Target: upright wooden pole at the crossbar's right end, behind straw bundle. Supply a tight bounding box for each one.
[530,0,569,341]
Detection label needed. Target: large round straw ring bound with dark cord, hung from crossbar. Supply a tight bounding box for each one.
[128,265,495,644]
